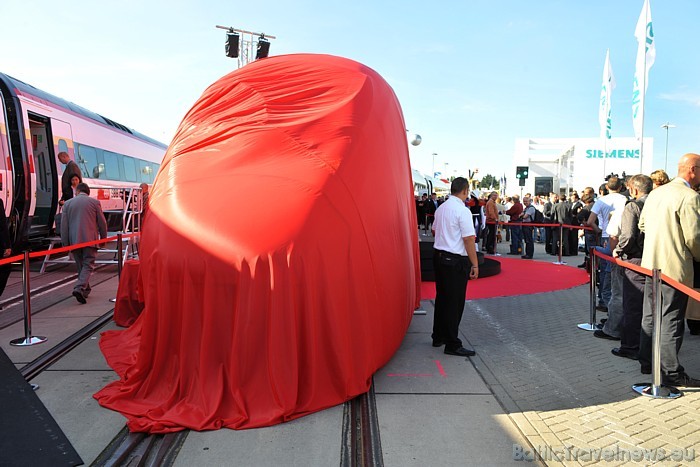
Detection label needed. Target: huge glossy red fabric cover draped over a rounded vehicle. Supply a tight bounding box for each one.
[95,55,420,433]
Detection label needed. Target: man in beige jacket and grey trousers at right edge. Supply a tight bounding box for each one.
[639,154,700,387]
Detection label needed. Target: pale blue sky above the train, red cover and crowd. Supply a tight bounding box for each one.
[0,0,700,185]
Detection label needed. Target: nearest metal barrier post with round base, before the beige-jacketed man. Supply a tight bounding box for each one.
[632,269,683,399]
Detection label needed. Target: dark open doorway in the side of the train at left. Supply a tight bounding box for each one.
[29,114,58,237]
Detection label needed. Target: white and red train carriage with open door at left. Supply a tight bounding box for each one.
[0,73,167,250]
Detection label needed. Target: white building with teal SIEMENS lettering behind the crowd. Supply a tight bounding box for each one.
[506,138,655,195]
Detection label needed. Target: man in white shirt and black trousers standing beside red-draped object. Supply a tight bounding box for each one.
[432,177,479,357]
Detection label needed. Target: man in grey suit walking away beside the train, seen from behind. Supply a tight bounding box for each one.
[61,183,107,303]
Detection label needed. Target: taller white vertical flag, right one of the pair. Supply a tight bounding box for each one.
[632,0,656,138]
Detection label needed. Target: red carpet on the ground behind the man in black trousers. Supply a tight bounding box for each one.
[421,256,589,300]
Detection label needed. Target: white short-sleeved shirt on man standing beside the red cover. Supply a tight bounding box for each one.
[433,196,476,256]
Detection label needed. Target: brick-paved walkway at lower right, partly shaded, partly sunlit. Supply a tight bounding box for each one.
[461,250,700,465]
